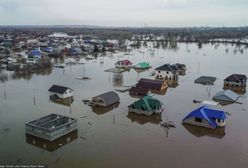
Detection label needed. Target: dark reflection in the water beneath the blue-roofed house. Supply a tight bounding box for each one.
[182,124,225,138]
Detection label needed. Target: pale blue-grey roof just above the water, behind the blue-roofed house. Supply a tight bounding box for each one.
[213,90,240,103]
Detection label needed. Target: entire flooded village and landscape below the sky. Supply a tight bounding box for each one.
[0,27,248,168]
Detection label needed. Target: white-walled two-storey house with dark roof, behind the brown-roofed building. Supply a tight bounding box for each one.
[155,64,179,81]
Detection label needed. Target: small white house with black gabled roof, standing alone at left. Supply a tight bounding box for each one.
[48,85,73,99]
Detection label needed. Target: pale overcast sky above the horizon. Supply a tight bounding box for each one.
[0,0,248,27]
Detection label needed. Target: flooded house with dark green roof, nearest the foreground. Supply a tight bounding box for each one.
[128,96,163,116]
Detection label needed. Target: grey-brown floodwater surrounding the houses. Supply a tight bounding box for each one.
[0,43,248,168]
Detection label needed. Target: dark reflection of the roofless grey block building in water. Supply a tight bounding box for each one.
[26,130,78,152]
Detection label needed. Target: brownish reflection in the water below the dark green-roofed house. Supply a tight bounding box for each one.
[127,112,162,125]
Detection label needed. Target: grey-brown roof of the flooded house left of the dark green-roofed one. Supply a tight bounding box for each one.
[92,91,120,106]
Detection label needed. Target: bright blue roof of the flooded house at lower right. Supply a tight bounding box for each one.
[183,106,226,128]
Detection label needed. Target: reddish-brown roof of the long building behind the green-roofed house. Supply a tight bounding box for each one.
[137,78,165,90]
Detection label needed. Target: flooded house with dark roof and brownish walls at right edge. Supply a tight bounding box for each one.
[224,74,247,91]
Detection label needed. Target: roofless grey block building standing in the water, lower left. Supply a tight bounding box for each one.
[25,114,77,141]
